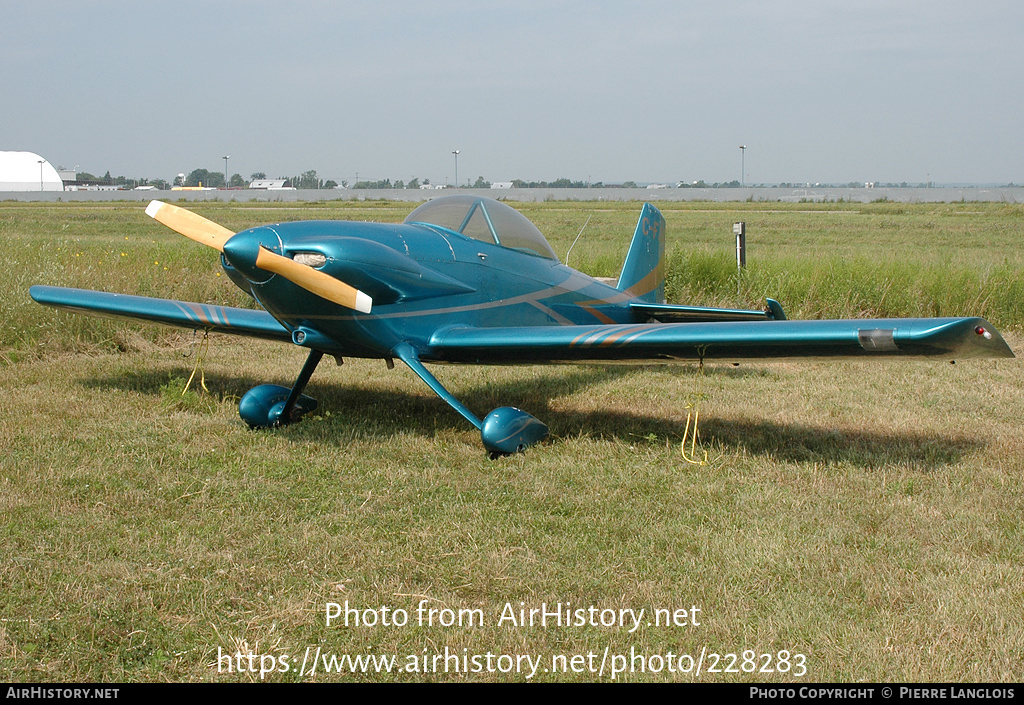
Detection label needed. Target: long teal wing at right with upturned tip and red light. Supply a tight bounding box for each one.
[424,318,1014,364]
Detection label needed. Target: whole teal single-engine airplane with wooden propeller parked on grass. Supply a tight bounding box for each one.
[31,195,1014,457]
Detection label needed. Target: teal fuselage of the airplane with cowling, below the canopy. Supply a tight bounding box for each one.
[221,221,637,361]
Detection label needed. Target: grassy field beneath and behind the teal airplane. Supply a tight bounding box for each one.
[0,202,1024,682]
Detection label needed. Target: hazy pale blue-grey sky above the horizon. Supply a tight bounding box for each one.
[0,0,1024,184]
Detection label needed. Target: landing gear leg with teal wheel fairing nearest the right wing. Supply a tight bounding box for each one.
[391,342,548,460]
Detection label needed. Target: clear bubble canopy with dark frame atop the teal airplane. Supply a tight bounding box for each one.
[406,196,558,260]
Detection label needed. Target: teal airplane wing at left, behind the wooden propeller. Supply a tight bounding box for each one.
[29,286,292,341]
